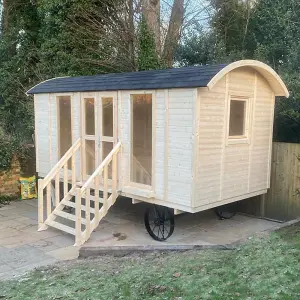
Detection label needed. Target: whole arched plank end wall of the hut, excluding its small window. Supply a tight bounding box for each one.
[194,67,274,207]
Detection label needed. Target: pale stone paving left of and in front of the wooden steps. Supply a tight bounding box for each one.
[0,200,78,280]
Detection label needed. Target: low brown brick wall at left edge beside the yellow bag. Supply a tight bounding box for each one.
[0,159,20,196]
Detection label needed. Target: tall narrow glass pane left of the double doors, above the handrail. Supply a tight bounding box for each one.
[58,96,72,164]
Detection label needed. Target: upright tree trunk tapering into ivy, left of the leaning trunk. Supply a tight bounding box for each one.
[142,0,161,55]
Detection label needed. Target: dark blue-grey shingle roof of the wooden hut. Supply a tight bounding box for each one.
[27,65,226,94]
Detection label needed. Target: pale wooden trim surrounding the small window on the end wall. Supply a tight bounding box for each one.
[226,95,251,145]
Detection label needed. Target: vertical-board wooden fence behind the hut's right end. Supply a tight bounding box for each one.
[240,143,300,221]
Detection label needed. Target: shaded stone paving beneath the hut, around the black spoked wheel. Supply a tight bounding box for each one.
[81,198,278,251]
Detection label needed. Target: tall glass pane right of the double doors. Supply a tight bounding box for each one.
[131,94,152,185]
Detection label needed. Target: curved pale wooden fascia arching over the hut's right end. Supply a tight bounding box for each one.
[207,60,290,98]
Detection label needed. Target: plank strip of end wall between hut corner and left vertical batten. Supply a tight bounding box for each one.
[194,77,226,207]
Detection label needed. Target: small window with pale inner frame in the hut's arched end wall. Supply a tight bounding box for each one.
[229,98,248,139]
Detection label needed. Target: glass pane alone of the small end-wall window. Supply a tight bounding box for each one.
[229,100,246,136]
